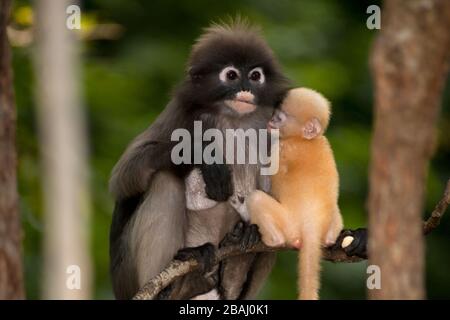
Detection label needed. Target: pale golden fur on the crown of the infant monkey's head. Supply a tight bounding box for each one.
[282,88,331,134]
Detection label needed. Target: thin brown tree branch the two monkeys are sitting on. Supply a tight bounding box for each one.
[133,180,450,300]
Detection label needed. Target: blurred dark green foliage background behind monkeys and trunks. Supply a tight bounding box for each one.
[13,0,450,299]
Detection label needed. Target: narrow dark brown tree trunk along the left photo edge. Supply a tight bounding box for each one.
[0,0,24,300]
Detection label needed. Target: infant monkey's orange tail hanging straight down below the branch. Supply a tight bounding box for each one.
[298,235,322,300]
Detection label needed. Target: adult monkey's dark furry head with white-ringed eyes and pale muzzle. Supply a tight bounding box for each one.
[178,23,288,117]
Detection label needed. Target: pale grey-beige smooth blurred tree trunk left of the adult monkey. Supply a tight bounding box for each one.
[35,0,91,299]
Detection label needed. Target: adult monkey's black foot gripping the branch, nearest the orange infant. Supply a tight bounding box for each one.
[219,221,261,250]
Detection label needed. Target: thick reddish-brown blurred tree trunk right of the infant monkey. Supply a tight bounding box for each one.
[369,0,450,299]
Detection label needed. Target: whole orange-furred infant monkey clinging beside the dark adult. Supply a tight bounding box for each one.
[247,88,343,299]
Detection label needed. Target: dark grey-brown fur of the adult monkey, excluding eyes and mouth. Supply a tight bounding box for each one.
[110,23,288,299]
